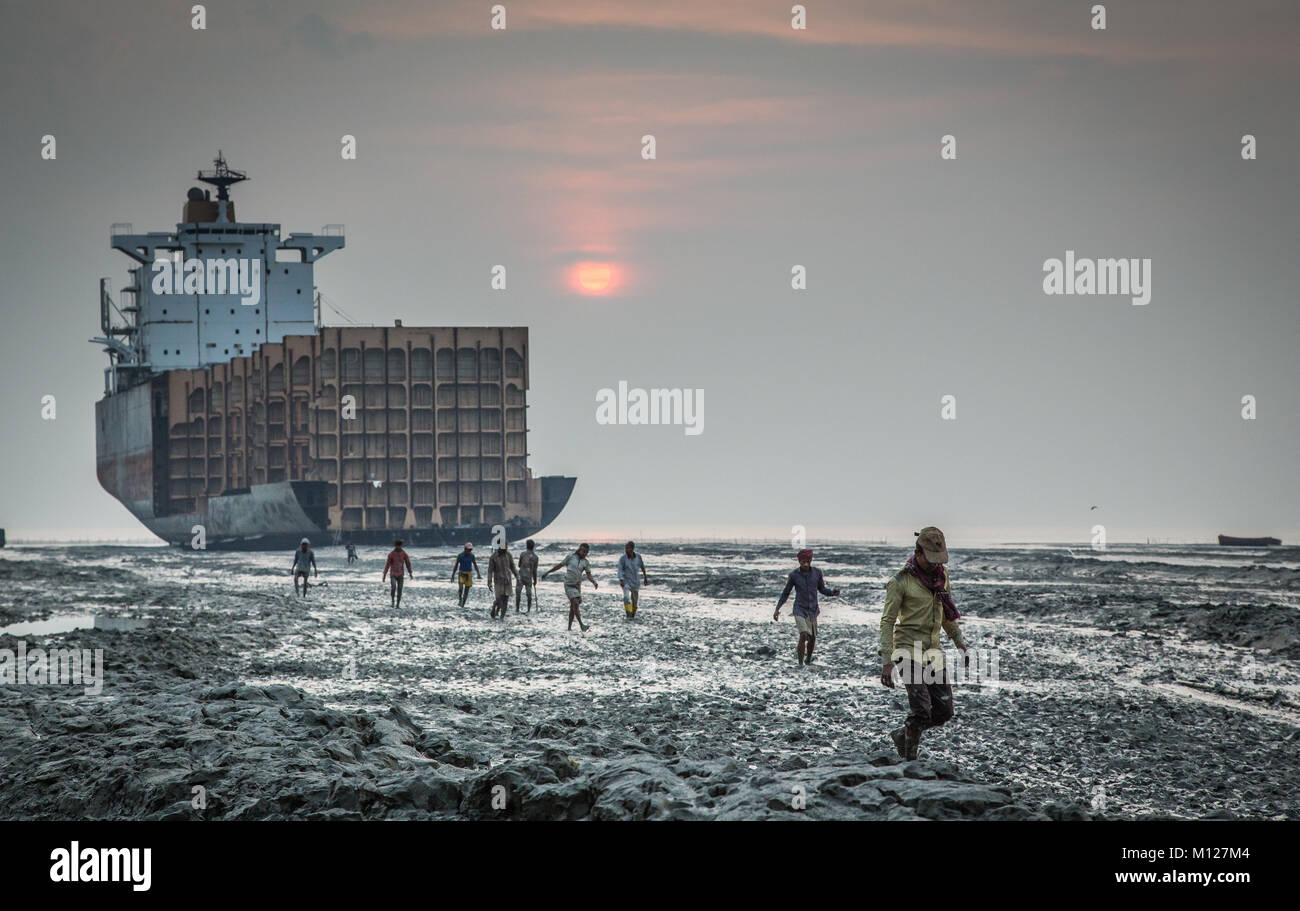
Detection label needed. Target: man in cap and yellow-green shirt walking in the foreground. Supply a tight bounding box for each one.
[880,525,966,759]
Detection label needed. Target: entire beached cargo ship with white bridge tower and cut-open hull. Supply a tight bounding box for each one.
[91,153,576,550]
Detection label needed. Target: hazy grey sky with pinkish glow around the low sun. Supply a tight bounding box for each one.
[0,0,1300,545]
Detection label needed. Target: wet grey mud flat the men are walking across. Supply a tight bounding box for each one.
[0,547,1300,819]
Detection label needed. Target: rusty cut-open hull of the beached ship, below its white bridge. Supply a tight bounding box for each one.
[96,327,576,550]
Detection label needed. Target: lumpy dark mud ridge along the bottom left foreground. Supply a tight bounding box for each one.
[0,649,1040,820]
